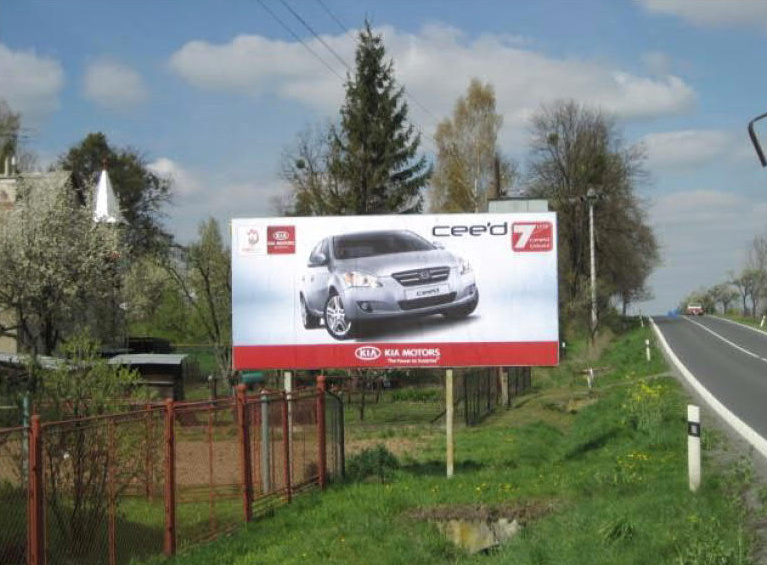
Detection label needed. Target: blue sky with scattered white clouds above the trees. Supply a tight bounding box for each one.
[0,0,767,313]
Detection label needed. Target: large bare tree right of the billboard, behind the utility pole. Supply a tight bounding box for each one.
[528,101,659,324]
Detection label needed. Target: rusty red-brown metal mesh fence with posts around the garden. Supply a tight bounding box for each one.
[0,383,344,565]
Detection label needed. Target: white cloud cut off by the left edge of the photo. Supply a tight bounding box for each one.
[0,44,64,123]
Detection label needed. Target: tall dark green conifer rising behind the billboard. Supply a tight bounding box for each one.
[330,21,431,214]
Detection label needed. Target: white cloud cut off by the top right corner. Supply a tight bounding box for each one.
[637,0,767,27]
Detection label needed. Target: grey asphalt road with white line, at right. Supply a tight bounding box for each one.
[653,316,767,438]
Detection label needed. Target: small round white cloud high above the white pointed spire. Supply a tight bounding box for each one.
[83,60,148,110]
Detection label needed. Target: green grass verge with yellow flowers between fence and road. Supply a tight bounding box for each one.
[136,322,751,565]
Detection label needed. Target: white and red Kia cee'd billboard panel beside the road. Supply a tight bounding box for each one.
[232,212,559,370]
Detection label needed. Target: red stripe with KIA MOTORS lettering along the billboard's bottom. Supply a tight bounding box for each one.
[233,341,559,370]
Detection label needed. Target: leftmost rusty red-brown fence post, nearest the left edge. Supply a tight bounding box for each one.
[27,415,46,565]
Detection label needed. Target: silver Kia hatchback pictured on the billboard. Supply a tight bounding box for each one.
[299,230,479,340]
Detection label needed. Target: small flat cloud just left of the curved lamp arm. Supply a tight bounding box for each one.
[642,130,736,169]
